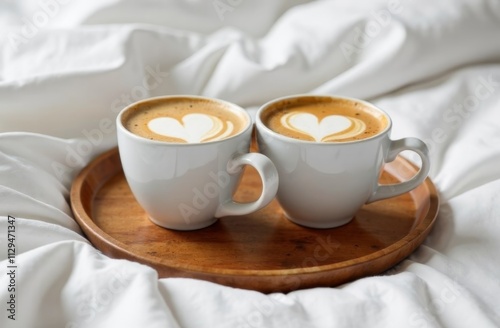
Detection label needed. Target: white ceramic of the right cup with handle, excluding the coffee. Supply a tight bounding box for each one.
[256,95,430,228]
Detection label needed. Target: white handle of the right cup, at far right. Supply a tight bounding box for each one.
[367,138,430,203]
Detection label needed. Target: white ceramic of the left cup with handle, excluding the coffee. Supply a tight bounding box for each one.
[116,96,278,230]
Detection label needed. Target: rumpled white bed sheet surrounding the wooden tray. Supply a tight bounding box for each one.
[0,0,500,328]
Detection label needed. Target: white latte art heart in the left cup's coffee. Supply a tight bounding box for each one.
[148,113,234,143]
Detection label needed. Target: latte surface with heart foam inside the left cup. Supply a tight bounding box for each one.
[122,97,249,143]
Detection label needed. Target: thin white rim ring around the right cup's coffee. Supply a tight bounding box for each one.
[255,93,392,147]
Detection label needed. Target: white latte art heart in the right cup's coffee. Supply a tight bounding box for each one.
[281,111,366,142]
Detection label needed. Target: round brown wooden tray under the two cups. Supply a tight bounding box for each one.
[71,148,439,292]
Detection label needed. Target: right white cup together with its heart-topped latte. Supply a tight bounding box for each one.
[256,95,430,228]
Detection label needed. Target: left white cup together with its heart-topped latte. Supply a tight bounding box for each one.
[116,96,278,230]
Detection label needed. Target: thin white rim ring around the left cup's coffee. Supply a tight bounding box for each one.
[116,94,253,147]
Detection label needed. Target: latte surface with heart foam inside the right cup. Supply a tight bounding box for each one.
[260,96,389,142]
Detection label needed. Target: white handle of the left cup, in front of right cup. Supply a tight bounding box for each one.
[215,153,279,218]
